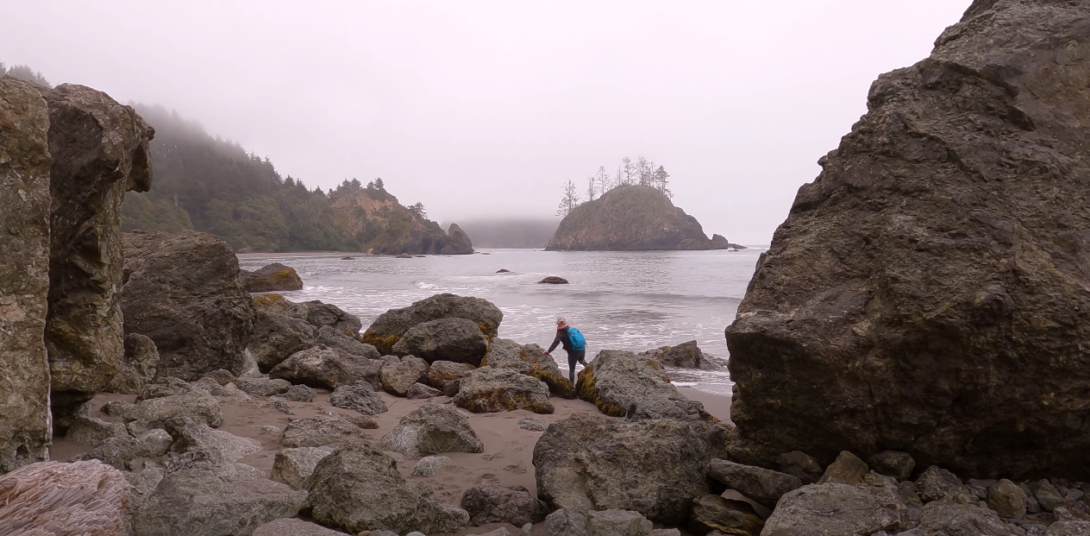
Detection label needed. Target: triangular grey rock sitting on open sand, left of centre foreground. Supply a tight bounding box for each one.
[380,404,484,458]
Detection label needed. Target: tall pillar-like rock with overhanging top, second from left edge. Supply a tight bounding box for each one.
[39,84,155,413]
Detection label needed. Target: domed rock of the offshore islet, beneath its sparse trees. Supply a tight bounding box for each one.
[545,185,729,252]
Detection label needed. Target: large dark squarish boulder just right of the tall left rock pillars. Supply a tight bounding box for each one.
[121,232,254,381]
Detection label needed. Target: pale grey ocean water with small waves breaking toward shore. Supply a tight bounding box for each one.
[239,246,766,395]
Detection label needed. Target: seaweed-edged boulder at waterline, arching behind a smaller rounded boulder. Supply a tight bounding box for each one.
[363,294,504,354]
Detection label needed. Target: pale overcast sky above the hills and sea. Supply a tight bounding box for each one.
[0,0,970,244]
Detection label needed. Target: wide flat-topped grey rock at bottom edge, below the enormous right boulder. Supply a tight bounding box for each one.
[762,483,909,536]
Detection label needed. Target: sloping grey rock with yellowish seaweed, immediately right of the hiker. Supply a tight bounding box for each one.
[575,350,714,421]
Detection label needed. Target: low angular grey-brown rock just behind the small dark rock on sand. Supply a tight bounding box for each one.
[269,346,383,390]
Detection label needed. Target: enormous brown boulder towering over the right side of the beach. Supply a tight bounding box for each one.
[726,0,1090,478]
